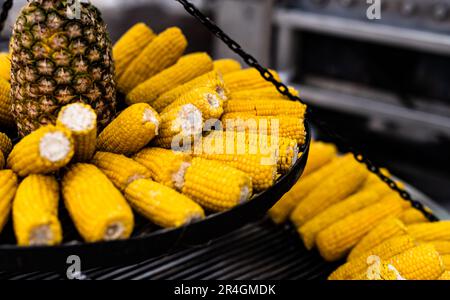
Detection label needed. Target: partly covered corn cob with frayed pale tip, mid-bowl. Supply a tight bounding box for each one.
[133,148,192,189]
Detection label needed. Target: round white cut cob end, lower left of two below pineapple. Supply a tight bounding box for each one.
[39,132,71,163]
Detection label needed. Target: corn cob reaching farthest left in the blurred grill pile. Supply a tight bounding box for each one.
[269,158,342,224]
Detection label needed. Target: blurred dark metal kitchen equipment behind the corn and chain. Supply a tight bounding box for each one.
[0,0,450,209]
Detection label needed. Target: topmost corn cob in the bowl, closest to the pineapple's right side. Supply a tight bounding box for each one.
[113,23,156,78]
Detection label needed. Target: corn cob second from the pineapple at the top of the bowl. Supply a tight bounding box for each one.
[118,27,187,94]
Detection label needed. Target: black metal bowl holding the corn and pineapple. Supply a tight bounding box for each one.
[0,122,311,271]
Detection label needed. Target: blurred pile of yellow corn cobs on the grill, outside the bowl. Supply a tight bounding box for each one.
[269,142,450,280]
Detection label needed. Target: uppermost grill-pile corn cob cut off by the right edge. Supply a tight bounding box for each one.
[408,221,450,241]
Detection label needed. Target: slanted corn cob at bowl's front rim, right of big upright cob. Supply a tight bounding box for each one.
[125,179,205,227]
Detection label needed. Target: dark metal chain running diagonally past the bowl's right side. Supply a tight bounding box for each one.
[176,0,439,222]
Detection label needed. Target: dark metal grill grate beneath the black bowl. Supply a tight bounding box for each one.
[0,220,337,280]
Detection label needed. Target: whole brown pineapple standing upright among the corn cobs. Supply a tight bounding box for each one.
[10,0,116,136]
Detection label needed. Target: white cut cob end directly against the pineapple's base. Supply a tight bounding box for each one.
[61,103,97,132]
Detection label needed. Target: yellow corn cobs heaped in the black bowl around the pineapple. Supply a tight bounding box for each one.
[0,24,305,246]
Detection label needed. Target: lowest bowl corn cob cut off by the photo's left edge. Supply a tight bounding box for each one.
[0,170,17,233]
